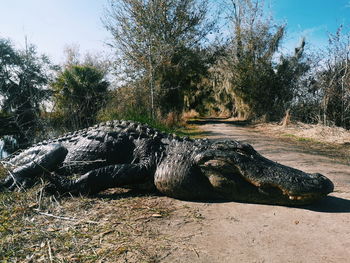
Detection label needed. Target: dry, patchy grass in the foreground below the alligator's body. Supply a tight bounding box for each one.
[0,165,199,262]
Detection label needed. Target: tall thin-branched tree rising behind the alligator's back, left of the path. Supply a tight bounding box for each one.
[104,0,212,116]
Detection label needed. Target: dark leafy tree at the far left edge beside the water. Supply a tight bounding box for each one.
[0,39,52,147]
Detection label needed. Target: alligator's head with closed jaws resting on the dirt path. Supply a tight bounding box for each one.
[194,141,334,205]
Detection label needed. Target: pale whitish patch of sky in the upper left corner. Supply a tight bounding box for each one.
[0,0,110,63]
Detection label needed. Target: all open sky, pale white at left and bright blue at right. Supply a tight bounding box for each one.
[0,0,350,63]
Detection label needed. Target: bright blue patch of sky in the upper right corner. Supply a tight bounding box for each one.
[270,0,350,52]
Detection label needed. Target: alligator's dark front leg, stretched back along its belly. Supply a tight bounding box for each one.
[47,164,154,195]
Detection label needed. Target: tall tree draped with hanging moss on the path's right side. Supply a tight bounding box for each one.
[216,0,308,119]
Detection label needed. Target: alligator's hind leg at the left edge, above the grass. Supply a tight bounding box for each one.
[0,144,68,191]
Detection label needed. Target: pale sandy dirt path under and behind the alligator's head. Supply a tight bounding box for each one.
[161,121,350,263]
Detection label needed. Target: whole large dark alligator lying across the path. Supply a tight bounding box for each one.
[0,120,334,206]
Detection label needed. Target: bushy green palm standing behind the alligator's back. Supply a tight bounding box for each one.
[52,65,109,129]
